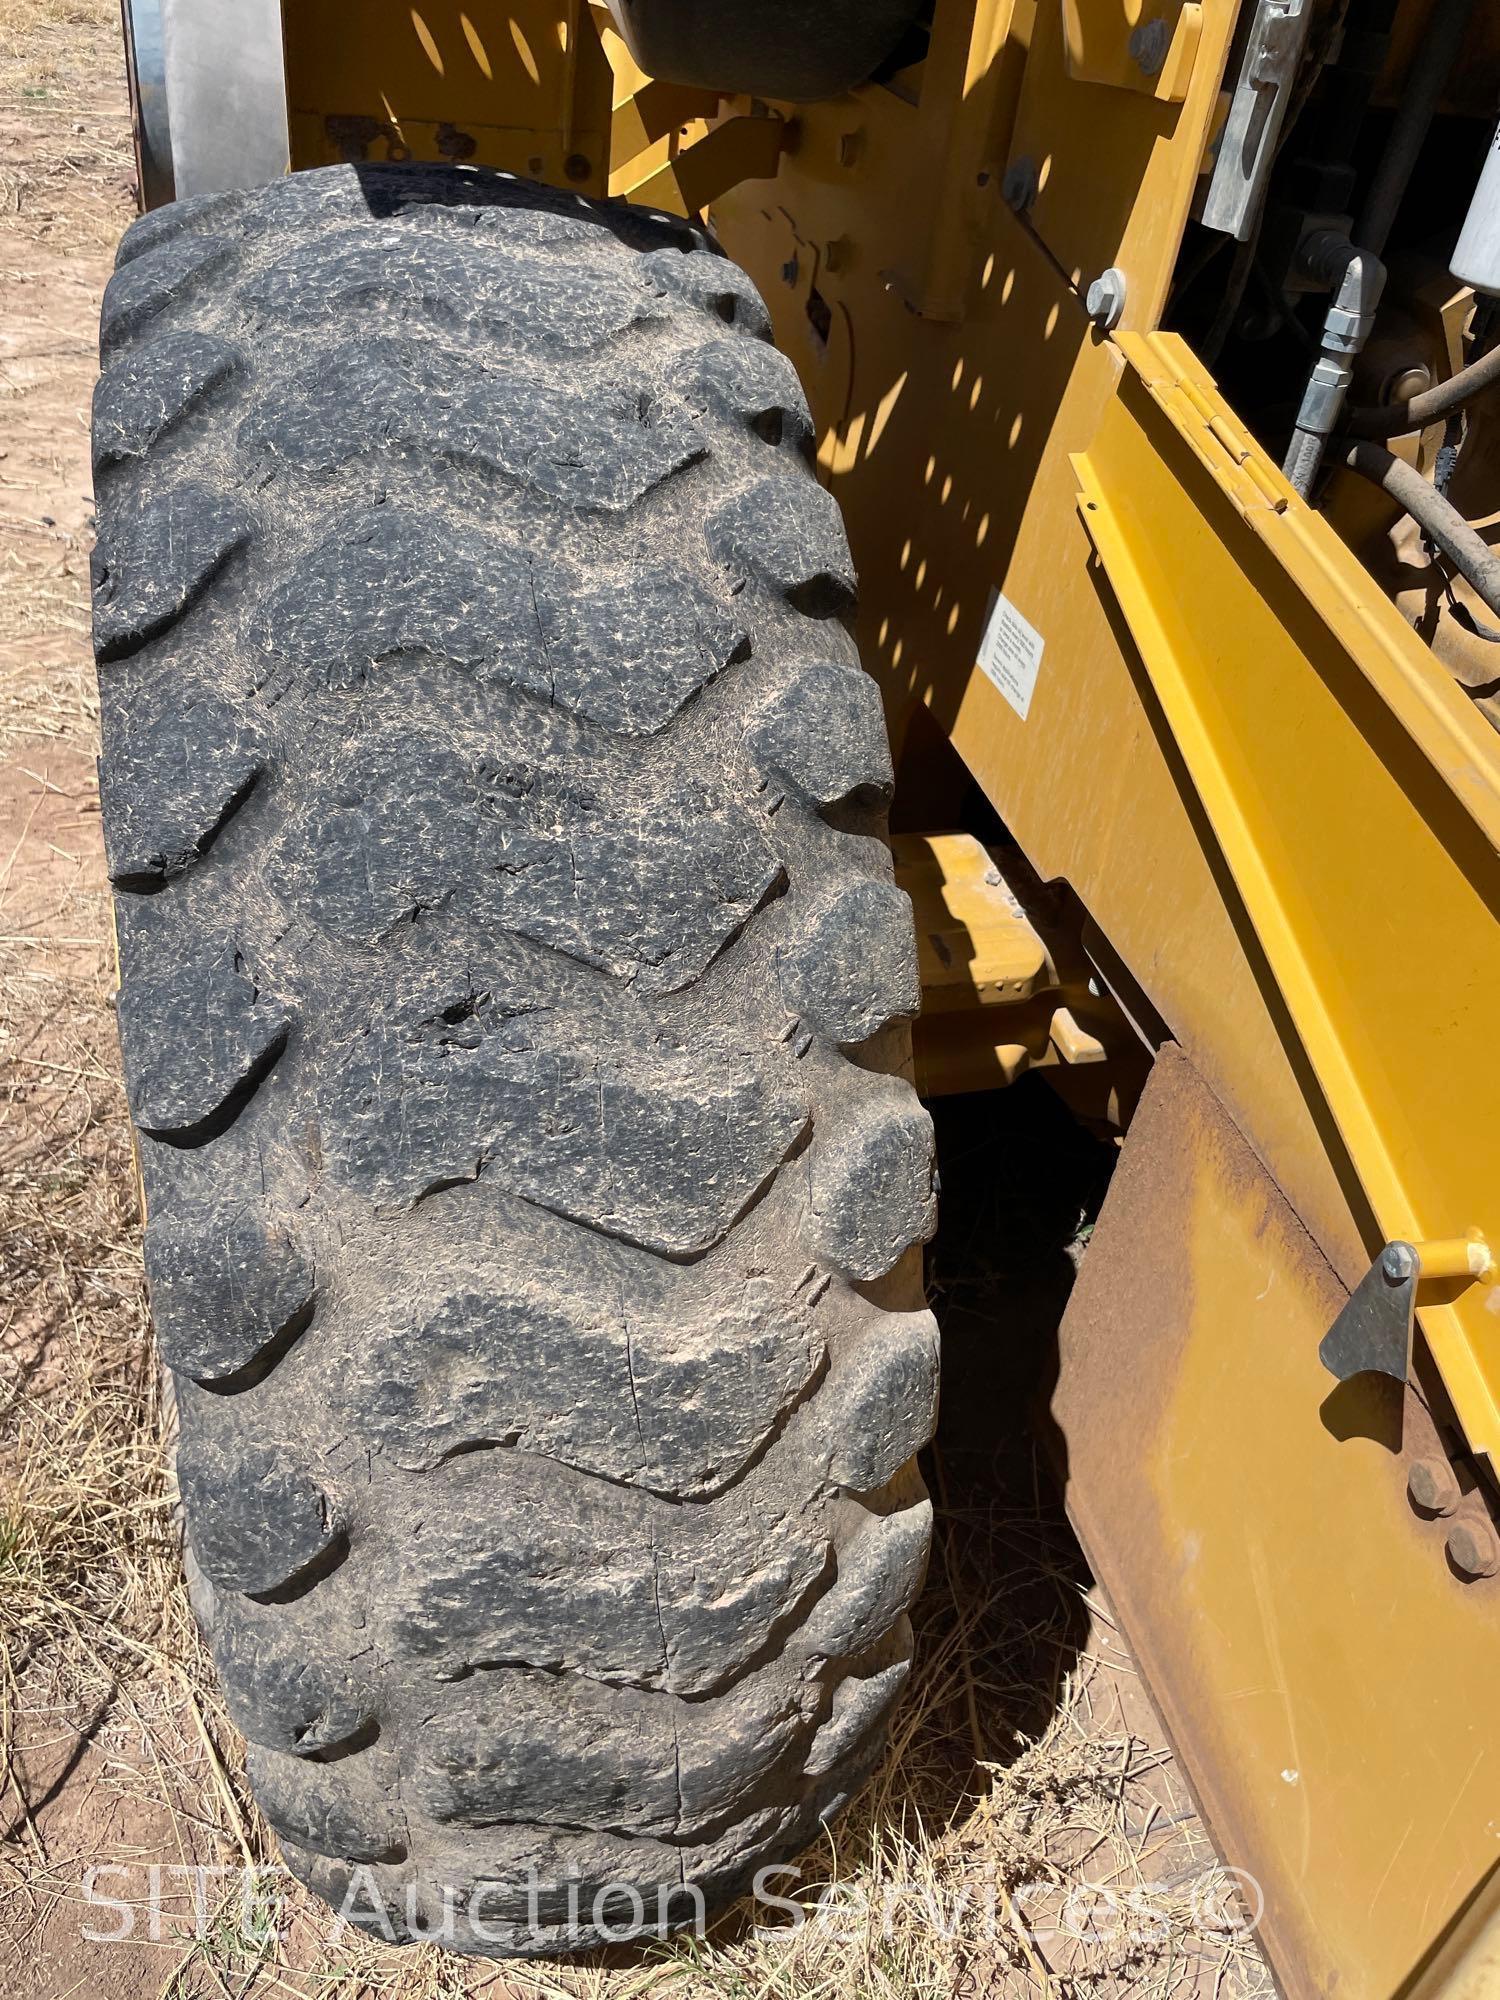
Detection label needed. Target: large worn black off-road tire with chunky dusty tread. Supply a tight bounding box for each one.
[94,168,936,1952]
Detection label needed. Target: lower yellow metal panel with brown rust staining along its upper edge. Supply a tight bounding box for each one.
[1052,1050,1500,2000]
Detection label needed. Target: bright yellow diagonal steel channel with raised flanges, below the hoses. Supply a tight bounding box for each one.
[1076,336,1500,1466]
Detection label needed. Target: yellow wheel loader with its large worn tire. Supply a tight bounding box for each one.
[94,0,1500,2000]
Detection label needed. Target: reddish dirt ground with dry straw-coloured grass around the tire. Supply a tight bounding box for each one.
[0,0,1270,2000]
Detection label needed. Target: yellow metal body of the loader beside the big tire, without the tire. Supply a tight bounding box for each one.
[276,0,1500,2000]
